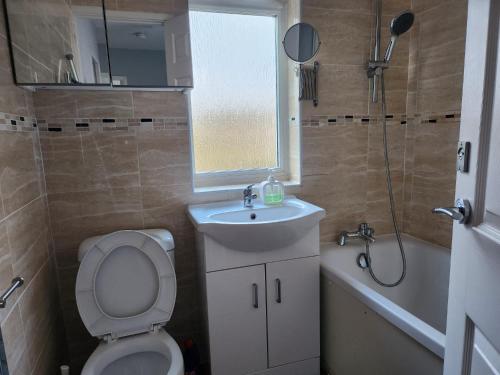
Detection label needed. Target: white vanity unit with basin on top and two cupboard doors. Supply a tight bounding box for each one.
[188,197,325,375]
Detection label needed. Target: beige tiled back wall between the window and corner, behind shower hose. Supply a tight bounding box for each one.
[299,0,410,241]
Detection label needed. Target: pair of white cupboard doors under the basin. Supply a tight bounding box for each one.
[201,256,319,375]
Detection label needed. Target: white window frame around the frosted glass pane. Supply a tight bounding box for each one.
[187,5,291,193]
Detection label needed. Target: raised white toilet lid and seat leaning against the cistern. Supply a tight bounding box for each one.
[76,231,177,337]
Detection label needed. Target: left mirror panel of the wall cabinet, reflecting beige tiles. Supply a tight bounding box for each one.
[5,0,110,86]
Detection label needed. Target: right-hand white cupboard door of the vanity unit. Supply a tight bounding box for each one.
[266,257,319,367]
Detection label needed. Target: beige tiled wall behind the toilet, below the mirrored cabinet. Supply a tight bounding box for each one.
[34,91,213,369]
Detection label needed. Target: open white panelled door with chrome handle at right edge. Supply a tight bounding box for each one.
[444,0,500,375]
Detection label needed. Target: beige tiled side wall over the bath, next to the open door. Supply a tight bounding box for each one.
[403,0,467,247]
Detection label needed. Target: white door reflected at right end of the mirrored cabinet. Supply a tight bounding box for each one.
[165,12,193,86]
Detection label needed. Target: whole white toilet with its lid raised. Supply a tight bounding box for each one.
[76,229,184,375]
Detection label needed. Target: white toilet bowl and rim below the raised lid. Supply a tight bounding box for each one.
[81,330,184,375]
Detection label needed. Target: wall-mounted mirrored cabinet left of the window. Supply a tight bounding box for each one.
[4,0,193,89]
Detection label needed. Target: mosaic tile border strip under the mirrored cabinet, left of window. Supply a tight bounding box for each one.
[38,117,188,133]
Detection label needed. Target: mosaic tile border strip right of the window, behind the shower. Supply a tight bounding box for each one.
[302,112,460,127]
